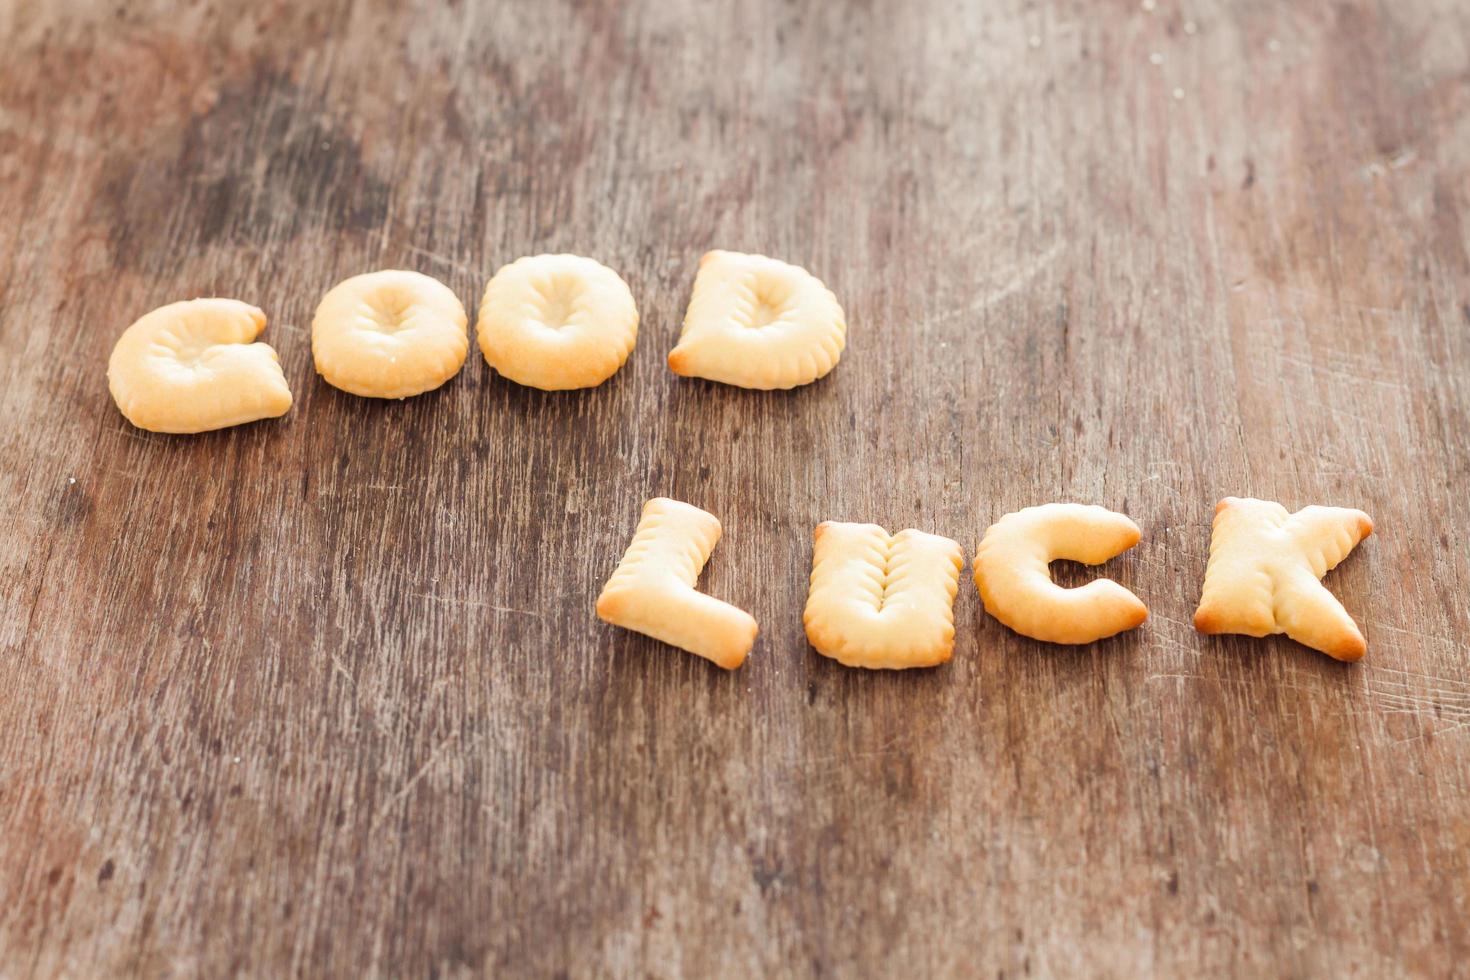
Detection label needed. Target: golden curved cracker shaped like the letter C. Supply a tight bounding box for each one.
[975,504,1148,644]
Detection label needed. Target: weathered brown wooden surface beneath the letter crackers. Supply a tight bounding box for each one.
[0,0,1470,977]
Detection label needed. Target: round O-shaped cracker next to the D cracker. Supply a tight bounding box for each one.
[476,256,638,391]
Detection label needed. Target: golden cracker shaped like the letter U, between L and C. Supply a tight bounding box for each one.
[801,520,964,670]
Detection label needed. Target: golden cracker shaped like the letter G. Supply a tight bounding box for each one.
[107,300,291,432]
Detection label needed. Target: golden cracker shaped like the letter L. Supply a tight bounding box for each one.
[597,497,756,670]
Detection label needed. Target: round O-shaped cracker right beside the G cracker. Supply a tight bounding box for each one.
[312,269,469,398]
